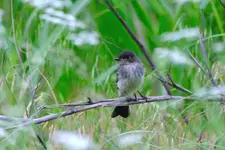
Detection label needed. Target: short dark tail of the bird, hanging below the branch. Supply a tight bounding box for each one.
[111,106,130,118]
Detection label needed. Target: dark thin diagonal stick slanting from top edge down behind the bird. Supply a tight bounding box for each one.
[105,0,172,95]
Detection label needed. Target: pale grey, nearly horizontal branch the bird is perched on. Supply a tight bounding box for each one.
[3,95,185,129]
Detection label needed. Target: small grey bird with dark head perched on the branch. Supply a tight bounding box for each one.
[111,51,145,118]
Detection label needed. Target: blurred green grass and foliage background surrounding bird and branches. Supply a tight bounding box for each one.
[0,0,225,150]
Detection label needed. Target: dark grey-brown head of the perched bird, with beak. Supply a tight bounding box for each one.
[115,50,140,64]
